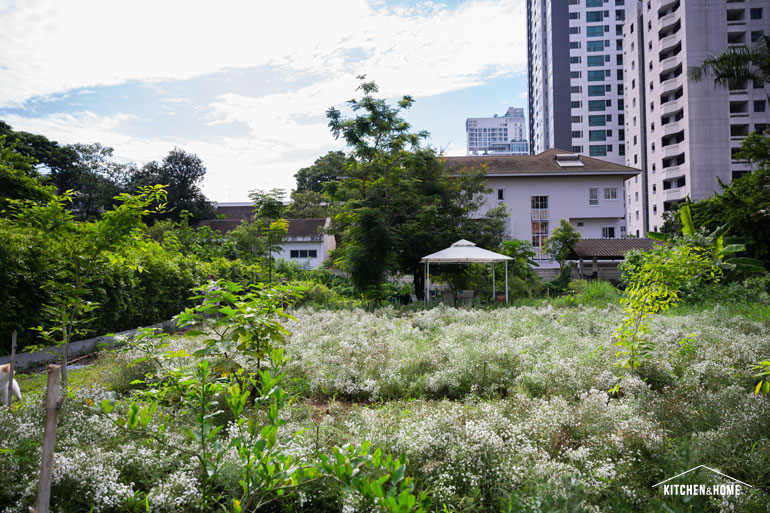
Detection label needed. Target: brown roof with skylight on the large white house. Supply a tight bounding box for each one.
[446,148,641,180]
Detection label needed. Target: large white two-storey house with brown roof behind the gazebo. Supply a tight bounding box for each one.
[446,148,640,267]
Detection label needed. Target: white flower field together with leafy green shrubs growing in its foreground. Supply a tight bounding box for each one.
[0,286,770,513]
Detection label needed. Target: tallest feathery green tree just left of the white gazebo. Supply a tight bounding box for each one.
[326,77,503,297]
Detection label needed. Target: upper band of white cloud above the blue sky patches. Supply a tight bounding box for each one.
[0,0,525,105]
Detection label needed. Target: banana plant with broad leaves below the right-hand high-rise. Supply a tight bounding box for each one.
[647,205,765,273]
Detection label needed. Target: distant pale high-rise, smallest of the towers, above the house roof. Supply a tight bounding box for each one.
[465,107,529,155]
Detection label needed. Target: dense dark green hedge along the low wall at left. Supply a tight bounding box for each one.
[0,219,262,354]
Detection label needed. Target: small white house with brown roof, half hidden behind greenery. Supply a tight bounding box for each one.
[275,217,336,269]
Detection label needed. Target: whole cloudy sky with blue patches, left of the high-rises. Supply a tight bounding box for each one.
[0,0,527,202]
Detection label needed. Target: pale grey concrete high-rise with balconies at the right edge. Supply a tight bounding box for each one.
[623,0,770,236]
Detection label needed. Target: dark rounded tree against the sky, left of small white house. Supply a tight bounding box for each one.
[129,148,216,225]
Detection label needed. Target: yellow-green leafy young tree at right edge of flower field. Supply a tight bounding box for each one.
[614,242,721,370]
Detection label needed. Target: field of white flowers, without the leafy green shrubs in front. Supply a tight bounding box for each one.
[0,304,770,513]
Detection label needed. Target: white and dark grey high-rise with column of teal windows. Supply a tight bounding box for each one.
[527,0,633,164]
